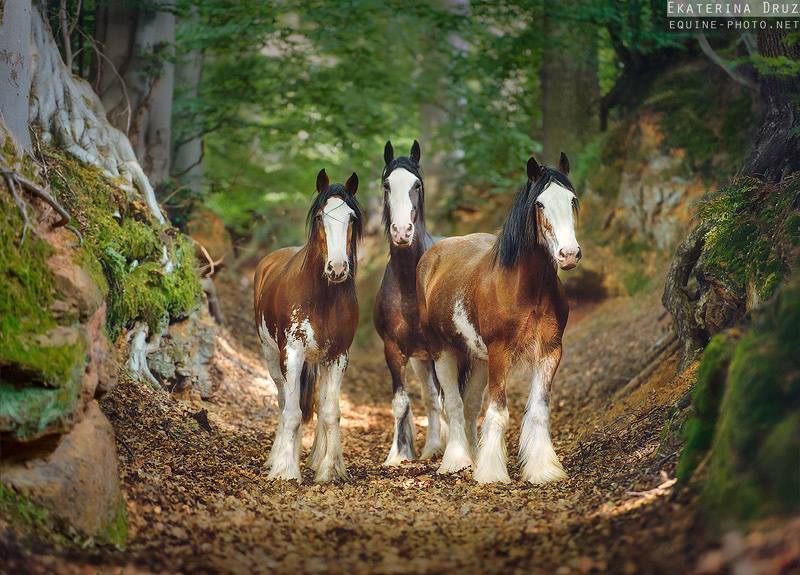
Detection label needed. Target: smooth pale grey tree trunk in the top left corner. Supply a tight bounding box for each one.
[0,0,33,152]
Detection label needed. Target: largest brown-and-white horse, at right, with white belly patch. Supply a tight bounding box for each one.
[417,153,581,483]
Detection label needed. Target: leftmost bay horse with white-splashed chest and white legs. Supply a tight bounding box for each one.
[254,169,362,482]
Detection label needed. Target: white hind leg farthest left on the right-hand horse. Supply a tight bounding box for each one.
[436,352,472,473]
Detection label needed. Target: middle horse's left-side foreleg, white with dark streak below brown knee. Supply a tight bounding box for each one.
[383,341,416,466]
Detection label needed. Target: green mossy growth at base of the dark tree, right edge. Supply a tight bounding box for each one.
[700,174,800,300]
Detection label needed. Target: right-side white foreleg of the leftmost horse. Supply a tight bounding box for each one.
[315,355,348,483]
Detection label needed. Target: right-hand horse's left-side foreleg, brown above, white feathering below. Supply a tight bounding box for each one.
[473,346,511,483]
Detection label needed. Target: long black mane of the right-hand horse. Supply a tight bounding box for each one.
[492,166,575,268]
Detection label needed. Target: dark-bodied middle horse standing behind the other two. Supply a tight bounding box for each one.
[373,140,445,466]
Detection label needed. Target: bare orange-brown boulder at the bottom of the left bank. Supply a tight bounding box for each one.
[0,401,124,540]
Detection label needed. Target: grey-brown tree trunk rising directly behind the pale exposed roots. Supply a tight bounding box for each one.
[95,0,175,185]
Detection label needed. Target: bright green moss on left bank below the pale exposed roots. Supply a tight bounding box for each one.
[48,150,201,339]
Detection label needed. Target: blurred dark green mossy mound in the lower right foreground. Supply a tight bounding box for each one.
[700,273,800,520]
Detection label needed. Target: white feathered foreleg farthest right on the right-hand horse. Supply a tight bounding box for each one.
[519,347,567,483]
